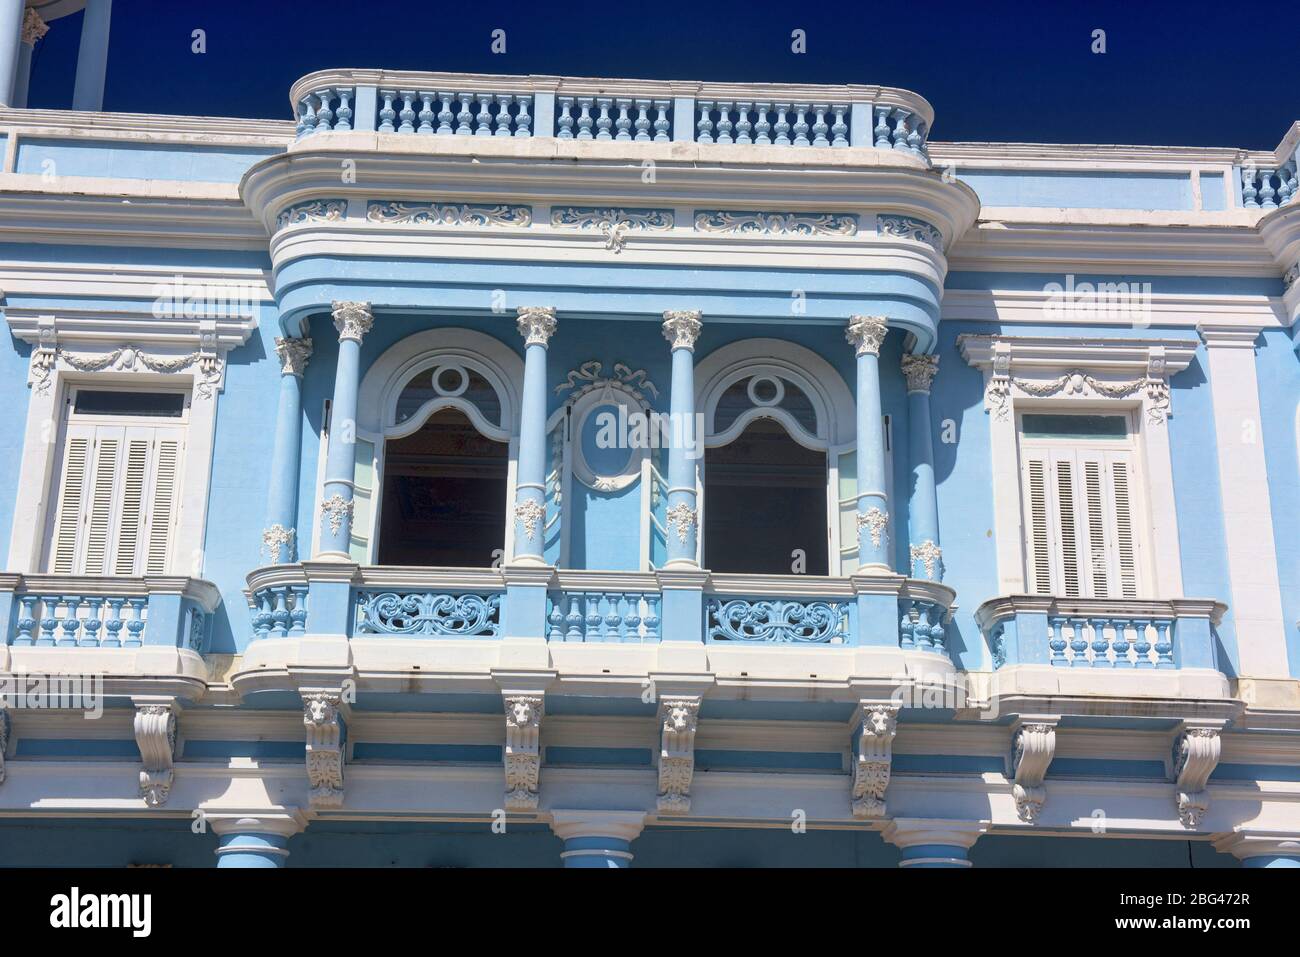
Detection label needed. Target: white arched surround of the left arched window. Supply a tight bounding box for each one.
[312,326,524,563]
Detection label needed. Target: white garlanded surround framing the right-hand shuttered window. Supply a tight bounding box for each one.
[957,335,1197,599]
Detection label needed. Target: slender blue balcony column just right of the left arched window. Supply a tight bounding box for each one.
[515,306,556,564]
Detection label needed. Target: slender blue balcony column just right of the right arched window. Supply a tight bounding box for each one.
[845,316,893,572]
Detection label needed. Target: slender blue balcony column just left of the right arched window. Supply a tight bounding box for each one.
[663,311,705,568]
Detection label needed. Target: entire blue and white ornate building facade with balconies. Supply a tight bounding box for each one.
[0,1,1300,867]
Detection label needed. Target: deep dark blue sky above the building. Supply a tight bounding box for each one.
[31,0,1300,150]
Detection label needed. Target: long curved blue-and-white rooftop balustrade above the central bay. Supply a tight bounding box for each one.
[290,70,933,161]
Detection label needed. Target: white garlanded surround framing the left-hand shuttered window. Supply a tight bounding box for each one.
[8,316,239,577]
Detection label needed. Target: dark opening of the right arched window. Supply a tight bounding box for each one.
[703,419,828,575]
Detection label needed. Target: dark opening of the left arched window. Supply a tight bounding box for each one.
[378,405,510,568]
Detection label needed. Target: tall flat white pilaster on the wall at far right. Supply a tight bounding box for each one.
[1200,325,1291,679]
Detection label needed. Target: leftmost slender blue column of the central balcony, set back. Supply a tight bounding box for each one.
[261,337,312,564]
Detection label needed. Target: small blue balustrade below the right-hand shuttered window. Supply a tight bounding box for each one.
[975,596,1227,671]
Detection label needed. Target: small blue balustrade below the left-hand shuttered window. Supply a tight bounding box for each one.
[0,575,221,654]
